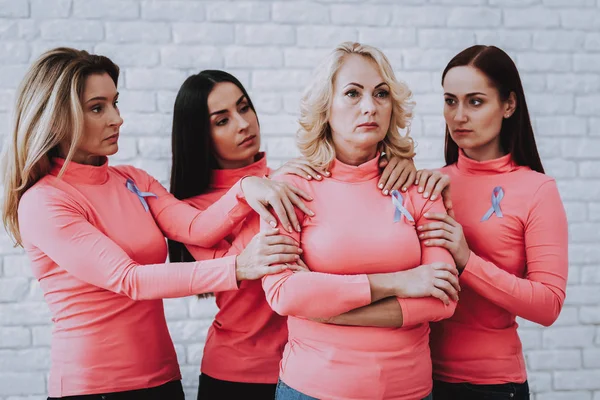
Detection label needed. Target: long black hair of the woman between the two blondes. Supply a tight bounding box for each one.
[168,70,256,262]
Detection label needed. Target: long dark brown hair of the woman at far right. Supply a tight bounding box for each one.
[442,45,544,173]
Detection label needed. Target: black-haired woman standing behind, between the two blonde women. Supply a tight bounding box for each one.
[169,70,442,399]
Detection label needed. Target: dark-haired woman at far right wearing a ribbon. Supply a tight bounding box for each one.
[419,46,568,400]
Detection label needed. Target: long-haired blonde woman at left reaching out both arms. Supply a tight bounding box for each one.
[2,48,310,399]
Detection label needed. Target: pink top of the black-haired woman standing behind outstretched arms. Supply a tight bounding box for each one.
[186,154,287,384]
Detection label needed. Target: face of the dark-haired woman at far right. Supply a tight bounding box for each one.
[443,66,516,158]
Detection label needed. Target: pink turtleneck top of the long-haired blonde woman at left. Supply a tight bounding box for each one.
[18,159,251,397]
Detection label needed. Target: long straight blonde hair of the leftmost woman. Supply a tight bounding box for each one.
[1,47,119,245]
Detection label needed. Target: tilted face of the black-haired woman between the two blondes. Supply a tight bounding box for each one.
[208,82,260,169]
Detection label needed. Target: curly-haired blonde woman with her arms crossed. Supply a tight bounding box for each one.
[251,43,459,400]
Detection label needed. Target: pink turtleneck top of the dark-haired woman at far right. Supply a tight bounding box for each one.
[431,151,568,384]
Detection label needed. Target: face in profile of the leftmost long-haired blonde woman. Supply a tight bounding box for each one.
[60,73,123,165]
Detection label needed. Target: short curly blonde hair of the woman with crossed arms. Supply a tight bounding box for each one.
[297,42,415,168]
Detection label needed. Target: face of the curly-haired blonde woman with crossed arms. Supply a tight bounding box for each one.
[329,54,392,161]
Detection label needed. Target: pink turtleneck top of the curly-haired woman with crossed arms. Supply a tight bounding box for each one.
[261,158,456,400]
